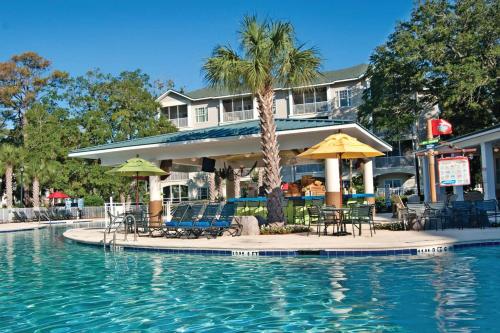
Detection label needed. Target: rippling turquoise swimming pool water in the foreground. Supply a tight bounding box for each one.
[0,227,500,333]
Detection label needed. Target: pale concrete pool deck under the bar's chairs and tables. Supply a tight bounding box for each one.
[64,228,500,255]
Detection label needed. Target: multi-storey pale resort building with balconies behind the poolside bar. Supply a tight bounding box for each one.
[154,64,415,201]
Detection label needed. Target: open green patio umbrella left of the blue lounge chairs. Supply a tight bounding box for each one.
[106,157,167,208]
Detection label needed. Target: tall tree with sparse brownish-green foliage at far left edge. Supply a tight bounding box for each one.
[0,52,67,144]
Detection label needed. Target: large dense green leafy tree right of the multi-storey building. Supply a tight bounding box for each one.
[360,0,500,138]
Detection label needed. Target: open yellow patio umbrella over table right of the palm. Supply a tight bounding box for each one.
[297,133,384,204]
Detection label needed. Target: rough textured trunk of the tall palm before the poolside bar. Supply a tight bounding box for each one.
[257,86,285,223]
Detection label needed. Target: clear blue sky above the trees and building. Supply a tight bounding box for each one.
[0,0,413,90]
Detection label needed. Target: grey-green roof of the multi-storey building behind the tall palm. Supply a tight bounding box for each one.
[183,64,368,99]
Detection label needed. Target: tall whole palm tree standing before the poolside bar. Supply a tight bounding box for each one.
[203,16,321,222]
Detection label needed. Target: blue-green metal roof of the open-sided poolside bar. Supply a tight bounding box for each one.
[70,119,353,154]
